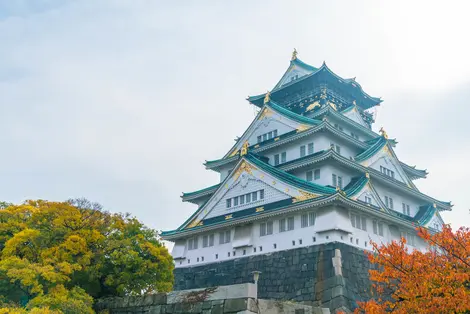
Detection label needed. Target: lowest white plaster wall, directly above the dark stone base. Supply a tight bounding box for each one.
[176,207,425,267]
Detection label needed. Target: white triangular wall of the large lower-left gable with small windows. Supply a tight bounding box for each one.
[206,178,291,218]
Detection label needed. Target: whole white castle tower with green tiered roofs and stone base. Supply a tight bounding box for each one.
[162,51,452,308]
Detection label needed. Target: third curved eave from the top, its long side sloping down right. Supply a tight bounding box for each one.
[278,150,453,210]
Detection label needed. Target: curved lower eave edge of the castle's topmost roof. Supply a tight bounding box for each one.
[247,63,383,109]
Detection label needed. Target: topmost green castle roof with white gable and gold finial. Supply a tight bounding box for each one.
[248,50,382,110]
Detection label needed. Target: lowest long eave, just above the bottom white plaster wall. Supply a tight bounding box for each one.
[161,193,422,241]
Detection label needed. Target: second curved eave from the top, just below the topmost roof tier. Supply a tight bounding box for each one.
[205,121,370,171]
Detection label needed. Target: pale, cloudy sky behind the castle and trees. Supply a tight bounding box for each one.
[0,0,470,230]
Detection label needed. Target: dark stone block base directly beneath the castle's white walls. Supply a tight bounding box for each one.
[174,242,371,310]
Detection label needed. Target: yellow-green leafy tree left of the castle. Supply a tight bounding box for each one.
[0,199,173,313]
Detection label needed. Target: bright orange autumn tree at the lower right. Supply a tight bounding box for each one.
[355,226,470,314]
